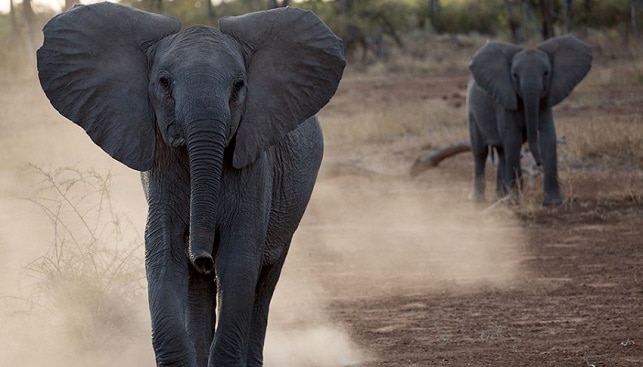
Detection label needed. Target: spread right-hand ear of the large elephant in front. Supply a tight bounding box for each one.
[219,7,346,168]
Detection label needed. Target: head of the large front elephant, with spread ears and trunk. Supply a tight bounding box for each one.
[38,3,345,273]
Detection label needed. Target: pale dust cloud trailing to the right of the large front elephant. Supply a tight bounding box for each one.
[266,170,525,366]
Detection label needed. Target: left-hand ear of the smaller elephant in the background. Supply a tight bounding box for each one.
[469,41,522,110]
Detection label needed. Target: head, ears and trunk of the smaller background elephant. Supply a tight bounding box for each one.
[469,35,592,164]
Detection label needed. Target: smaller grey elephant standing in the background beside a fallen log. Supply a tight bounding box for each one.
[467,34,592,206]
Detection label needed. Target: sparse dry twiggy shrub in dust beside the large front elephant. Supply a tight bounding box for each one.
[24,167,145,351]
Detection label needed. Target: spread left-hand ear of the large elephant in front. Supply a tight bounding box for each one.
[37,3,180,171]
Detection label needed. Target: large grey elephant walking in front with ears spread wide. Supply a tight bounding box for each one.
[37,2,345,367]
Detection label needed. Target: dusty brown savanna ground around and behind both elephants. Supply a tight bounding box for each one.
[0,34,643,367]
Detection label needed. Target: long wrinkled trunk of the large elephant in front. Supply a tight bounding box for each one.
[186,118,225,274]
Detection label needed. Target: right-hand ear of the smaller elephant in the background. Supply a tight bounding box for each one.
[537,34,592,106]
